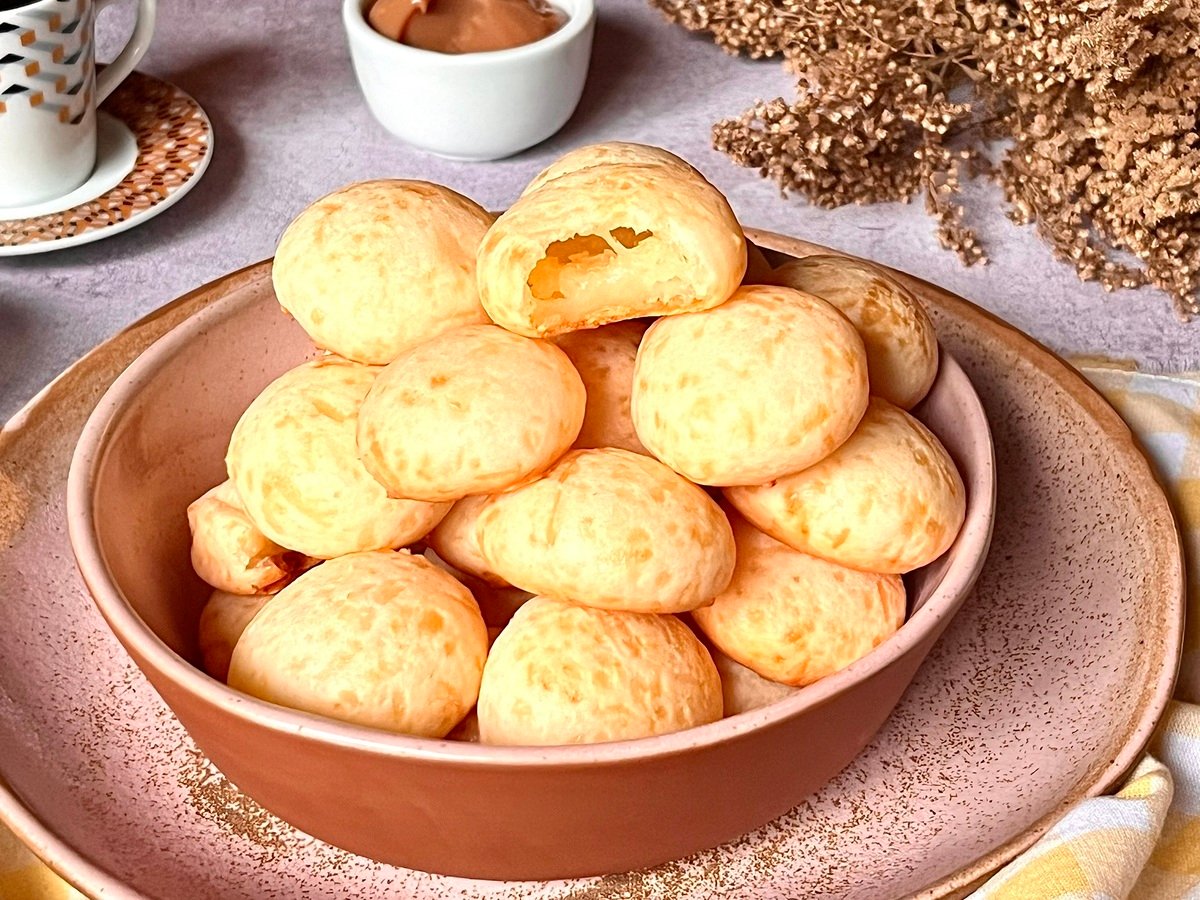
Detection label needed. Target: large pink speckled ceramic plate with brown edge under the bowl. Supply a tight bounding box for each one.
[0,235,1183,900]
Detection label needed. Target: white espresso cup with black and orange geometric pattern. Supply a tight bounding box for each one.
[0,0,155,212]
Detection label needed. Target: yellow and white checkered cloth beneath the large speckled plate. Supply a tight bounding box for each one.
[0,367,1200,900]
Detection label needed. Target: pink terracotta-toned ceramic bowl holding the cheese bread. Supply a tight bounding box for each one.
[67,264,995,880]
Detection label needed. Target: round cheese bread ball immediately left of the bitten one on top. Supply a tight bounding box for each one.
[271,180,493,365]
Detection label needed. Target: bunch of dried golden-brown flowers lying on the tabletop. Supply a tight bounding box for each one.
[652,0,1200,317]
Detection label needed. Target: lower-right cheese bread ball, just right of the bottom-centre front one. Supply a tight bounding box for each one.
[692,517,905,685]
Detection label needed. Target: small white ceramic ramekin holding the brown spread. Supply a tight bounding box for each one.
[342,0,595,160]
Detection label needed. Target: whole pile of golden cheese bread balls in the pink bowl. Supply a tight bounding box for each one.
[188,143,965,744]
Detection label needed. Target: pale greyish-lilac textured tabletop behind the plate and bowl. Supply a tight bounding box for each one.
[0,0,1200,421]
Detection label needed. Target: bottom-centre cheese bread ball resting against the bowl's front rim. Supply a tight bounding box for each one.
[478,596,721,745]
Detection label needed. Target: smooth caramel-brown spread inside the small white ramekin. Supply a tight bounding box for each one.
[367,0,566,53]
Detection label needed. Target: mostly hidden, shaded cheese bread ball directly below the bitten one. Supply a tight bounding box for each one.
[554,319,650,456]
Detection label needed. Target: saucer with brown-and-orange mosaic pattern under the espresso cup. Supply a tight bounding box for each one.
[0,72,212,257]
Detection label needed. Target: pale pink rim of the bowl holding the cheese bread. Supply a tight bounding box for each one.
[66,280,996,768]
